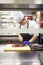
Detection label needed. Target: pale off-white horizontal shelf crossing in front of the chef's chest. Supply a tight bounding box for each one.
[0,28,43,35]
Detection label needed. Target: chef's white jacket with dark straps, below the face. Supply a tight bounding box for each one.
[21,20,39,36]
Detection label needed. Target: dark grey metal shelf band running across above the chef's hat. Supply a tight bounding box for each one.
[0,4,43,10]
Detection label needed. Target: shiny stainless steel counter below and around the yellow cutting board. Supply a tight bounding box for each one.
[0,45,43,65]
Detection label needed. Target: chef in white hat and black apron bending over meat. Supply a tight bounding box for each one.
[10,11,39,44]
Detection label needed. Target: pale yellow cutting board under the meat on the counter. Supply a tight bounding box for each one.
[4,44,31,52]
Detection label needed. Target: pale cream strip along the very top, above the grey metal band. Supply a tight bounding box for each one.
[0,0,43,4]
